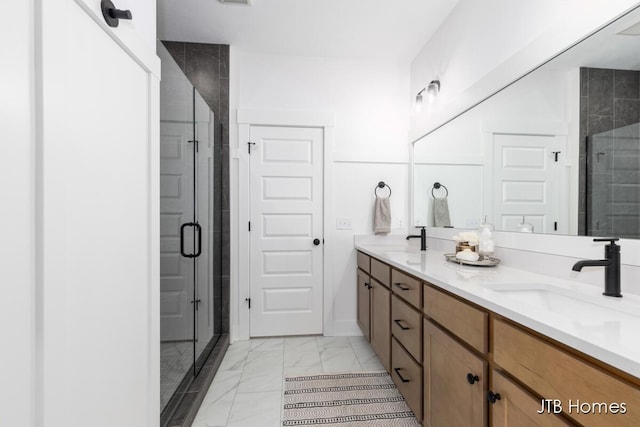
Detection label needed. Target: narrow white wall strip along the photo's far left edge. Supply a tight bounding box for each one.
[0,0,36,427]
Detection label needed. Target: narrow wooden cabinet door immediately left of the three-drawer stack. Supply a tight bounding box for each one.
[371,279,391,372]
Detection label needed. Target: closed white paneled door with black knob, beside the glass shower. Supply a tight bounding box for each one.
[249,126,323,337]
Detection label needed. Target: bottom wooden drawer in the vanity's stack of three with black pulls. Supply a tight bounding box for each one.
[391,338,422,420]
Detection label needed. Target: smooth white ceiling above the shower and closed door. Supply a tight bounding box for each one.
[158,0,459,61]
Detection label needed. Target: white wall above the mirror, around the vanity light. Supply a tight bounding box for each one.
[409,0,637,140]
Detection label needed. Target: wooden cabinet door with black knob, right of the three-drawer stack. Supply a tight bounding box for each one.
[423,320,487,427]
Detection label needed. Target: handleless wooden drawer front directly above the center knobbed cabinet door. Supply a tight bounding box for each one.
[424,285,489,354]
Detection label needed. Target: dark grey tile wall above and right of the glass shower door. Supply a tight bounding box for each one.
[162,41,230,334]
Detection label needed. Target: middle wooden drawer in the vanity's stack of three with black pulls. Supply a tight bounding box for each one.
[391,295,422,361]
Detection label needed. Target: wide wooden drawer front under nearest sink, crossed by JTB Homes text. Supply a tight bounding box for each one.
[493,319,640,427]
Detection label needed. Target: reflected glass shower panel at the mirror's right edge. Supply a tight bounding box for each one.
[585,123,640,239]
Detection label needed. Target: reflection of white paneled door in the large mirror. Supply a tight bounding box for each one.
[491,133,567,233]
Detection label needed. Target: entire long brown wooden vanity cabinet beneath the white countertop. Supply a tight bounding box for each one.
[357,252,640,427]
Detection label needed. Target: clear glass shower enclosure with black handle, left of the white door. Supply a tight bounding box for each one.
[158,43,222,418]
